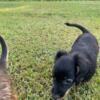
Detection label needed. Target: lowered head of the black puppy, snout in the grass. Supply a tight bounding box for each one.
[52,51,75,100]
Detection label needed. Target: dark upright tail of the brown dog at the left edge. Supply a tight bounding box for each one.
[0,36,7,63]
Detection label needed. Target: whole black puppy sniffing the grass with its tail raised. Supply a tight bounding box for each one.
[52,23,99,100]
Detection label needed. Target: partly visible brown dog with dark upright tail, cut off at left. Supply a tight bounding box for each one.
[0,36,18,100]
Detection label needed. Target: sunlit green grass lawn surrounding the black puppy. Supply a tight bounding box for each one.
[0,1,100,100]
